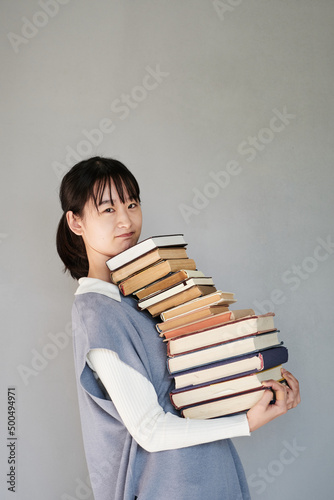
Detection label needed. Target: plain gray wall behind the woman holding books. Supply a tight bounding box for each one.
[0,0,334,500]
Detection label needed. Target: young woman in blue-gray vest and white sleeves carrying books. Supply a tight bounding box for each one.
[57,157,300,500]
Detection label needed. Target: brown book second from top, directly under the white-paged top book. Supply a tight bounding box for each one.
[111,247,188,286]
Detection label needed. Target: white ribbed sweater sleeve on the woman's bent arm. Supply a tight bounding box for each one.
[87,349,250,452]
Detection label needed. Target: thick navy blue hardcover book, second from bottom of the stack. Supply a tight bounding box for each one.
[172,345,288,389]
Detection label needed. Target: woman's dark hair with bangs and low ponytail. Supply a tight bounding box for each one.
[56,156,140,279]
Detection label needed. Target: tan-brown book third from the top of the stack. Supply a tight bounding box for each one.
[118,259,196,295]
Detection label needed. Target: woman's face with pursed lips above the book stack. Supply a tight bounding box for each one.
[77,183,142,267]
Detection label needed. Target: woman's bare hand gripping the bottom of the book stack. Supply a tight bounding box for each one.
[247,368,300,432]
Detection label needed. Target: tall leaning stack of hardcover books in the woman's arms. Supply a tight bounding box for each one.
[107,234,288,419]
